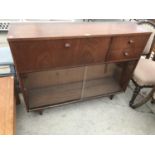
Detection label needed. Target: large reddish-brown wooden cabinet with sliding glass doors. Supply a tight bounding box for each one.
[8,22,151,111]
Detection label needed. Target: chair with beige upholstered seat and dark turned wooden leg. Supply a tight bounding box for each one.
[129,20,155,108]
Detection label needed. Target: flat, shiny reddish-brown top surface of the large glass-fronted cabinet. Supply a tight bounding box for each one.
[8,22,150,41]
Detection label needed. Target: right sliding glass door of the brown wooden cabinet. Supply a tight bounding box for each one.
[82,64,122,98]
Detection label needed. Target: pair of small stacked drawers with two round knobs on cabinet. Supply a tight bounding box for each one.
[107,35,149,61]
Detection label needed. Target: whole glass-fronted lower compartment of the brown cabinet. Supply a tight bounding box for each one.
[23,63,124,109]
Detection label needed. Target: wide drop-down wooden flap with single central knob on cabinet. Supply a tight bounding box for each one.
[11,37,110,72]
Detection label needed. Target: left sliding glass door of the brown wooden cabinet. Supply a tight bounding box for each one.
[23,67,84,109]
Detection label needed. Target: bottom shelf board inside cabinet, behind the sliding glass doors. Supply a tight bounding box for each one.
[28,76,121,109]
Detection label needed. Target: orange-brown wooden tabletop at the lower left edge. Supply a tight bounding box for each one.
[0,76,15,135]
